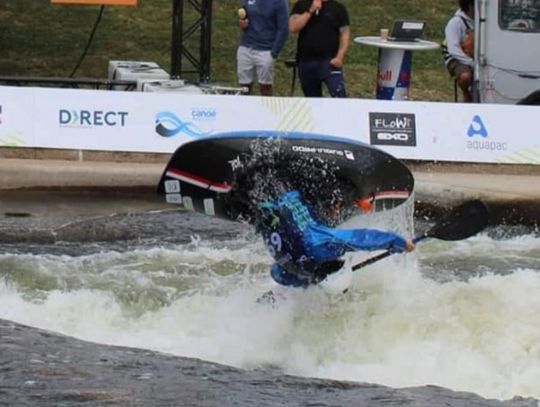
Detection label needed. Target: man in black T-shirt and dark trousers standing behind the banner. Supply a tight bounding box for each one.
[289,0,351,98]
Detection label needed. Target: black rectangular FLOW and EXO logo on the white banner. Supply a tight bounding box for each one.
[369,113,416,147]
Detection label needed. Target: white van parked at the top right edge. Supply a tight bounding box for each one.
[474,0,540,105]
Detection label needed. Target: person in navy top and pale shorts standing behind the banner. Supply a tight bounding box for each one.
[236,0,289,96]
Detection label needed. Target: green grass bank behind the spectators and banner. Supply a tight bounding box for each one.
[0,0,457,101]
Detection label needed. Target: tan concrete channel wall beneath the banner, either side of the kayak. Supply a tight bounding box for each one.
[0,148,540,225]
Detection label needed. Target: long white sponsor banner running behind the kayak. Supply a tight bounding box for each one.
[0,87,540,164]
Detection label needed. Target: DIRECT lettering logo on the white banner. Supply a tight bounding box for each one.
[58,109,128,127]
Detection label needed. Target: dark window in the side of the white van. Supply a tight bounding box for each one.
[499,0,540,33]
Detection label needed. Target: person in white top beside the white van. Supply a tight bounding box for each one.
[442,0,474,102]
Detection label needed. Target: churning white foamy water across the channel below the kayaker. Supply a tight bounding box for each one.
[0,231,540,399]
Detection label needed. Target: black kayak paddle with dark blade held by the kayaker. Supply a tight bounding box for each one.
[352,200,488,271]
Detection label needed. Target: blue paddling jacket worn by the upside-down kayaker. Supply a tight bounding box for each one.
[257,190,406,287]
